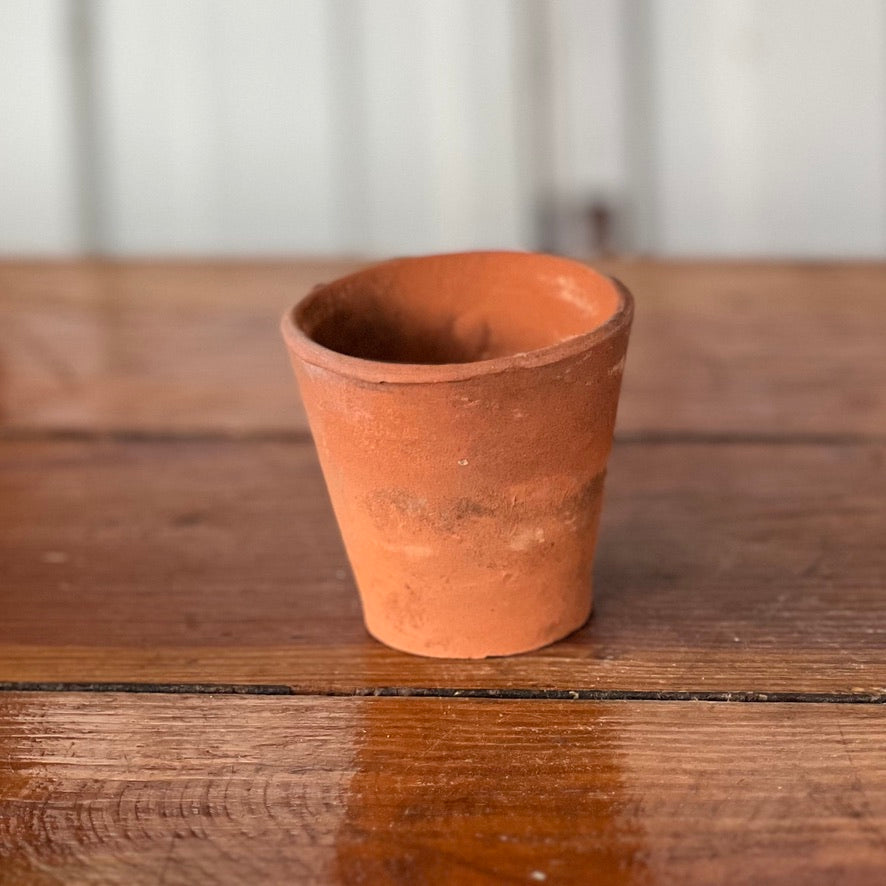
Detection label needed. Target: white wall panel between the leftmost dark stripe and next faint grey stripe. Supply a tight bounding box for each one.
[87,0,339,253]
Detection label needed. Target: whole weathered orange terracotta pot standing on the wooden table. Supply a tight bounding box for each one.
[282,252,633,658]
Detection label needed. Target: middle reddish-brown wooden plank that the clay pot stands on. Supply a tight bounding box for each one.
[0,439,886,694]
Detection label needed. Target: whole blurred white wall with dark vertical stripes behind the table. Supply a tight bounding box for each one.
[0,0,886,258]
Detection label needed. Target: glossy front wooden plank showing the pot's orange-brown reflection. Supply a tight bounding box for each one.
[0,693,886,886]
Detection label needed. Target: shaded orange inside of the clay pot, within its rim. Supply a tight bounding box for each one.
[295,252,619,364]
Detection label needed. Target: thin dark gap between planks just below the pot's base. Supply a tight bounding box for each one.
[0,681,886,704]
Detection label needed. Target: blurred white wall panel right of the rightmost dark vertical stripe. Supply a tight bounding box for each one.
[645,0,886,256]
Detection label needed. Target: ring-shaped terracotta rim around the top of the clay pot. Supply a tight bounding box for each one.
[280,250,634,384]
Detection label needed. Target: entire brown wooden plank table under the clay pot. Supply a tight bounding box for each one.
[0,261,886,884]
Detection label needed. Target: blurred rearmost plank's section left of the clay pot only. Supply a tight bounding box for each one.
[0,262,353,432]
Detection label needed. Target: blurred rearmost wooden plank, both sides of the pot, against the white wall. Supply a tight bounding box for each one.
[0,260,886,435]
